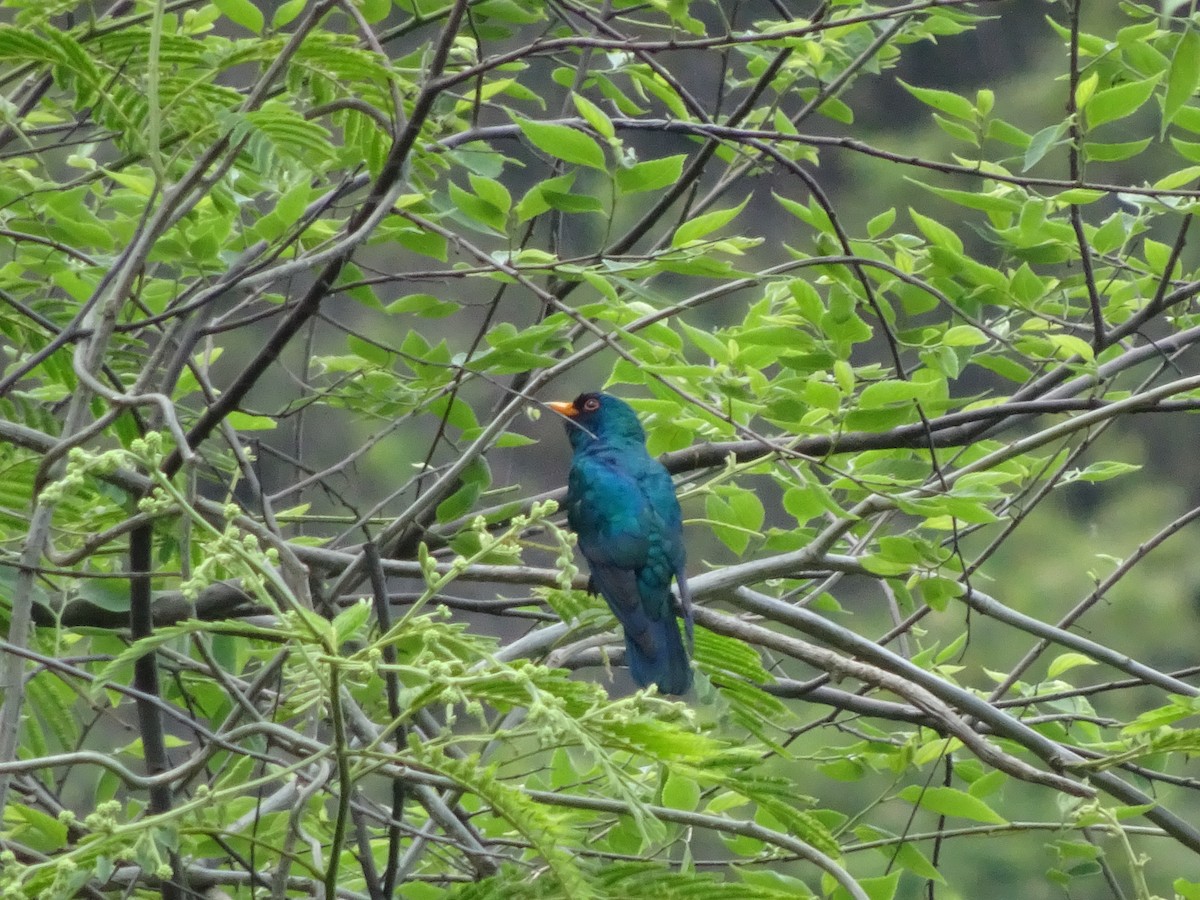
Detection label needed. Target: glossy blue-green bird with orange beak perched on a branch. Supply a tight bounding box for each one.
[548,394,692,694]
